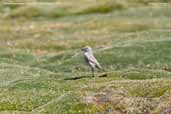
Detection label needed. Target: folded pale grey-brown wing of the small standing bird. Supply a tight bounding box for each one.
[85,53,101,68]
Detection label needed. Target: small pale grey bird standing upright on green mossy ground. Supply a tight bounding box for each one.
[82,46,104,77]
